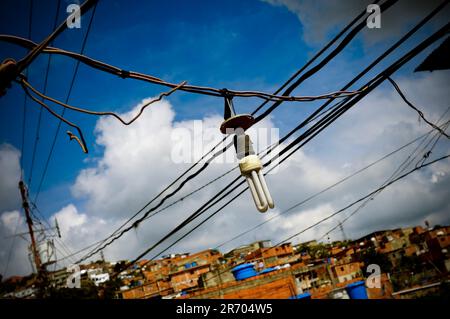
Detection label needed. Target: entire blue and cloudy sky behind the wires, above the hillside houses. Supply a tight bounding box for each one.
[0,0,450,276]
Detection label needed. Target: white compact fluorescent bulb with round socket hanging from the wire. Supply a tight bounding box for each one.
[220,91,275,213]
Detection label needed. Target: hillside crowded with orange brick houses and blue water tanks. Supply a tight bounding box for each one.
[1,225,450,299]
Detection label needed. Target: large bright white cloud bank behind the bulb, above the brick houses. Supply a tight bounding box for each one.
[2,73,450,276]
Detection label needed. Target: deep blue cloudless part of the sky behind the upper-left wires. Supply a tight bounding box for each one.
[0,1,308,211]
